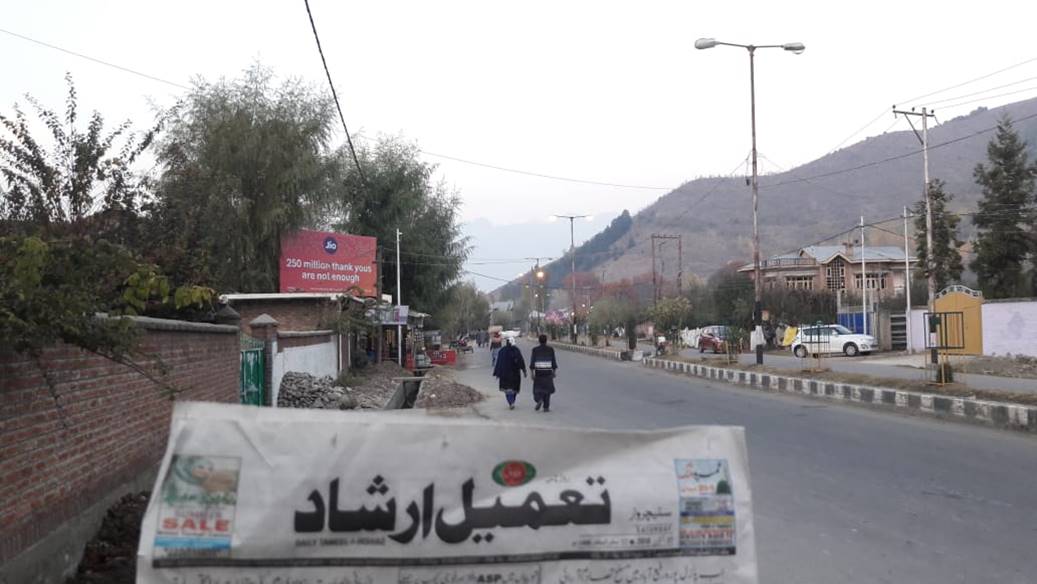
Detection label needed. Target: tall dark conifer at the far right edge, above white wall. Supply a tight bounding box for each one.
[971,117,1037,298]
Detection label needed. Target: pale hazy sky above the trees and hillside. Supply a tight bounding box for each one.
[0,0,1037,288]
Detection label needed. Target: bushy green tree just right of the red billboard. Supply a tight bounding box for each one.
[330,138,469,315]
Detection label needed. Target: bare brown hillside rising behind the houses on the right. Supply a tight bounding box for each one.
[499,99,1037,296]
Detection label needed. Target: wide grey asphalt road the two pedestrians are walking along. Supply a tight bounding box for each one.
[458,343,1037,584]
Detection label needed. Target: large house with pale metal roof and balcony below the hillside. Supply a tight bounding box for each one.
[738,244,918,300]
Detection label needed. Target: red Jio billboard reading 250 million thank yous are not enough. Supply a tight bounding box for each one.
[280,230,377,297]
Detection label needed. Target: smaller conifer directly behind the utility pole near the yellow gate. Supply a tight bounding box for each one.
[912,178,962,290]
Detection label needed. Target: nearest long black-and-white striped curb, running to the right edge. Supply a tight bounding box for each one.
[644,357,1037,433]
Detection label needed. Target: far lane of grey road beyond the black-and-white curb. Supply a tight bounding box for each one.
[680,349,1037,392]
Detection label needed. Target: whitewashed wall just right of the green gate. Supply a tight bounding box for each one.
[271,331,338,406]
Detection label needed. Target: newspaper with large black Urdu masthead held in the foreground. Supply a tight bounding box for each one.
[137,402,757,584]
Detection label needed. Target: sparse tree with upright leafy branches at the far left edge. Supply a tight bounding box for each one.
[0,75,158,244]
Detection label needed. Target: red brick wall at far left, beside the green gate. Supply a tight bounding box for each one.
[0,322,240,563]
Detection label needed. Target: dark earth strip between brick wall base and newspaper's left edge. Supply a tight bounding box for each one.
[65,491,149,584]
